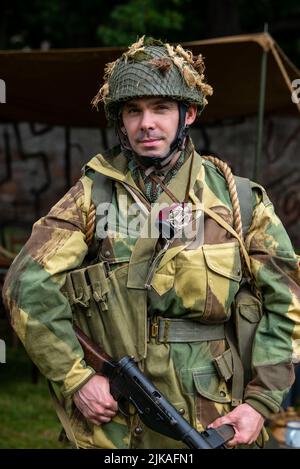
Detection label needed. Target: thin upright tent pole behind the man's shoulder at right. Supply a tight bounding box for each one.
[253,23,269,181]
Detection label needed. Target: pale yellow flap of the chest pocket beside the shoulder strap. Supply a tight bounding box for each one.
[203,243,242,282]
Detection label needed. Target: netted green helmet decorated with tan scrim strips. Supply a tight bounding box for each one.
[92,36,213,122]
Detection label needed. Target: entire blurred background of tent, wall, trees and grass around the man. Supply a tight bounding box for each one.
[0,0,300,448]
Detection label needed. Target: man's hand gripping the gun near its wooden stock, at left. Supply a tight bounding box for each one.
[73,375,118,425]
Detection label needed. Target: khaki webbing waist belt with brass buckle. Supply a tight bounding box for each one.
[147,316,225,343]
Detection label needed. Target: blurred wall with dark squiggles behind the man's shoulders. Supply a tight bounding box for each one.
[0,117,300,249]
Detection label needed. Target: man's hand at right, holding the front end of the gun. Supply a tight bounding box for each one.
[208,404,264,448]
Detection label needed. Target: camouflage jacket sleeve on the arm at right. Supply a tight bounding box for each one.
[245,185,300,417]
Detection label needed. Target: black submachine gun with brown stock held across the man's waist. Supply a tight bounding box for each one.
[73,325,234,449]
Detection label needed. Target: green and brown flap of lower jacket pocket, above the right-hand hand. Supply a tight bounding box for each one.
[193,366,231,404]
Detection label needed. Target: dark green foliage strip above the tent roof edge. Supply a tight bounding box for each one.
[0,0,300,63]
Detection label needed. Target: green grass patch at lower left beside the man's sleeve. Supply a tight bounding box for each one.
[0,345,62,449]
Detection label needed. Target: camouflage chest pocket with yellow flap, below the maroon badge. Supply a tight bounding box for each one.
[152,241,242,322]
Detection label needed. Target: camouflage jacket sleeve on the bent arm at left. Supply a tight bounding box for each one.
[3,178,94,395]
